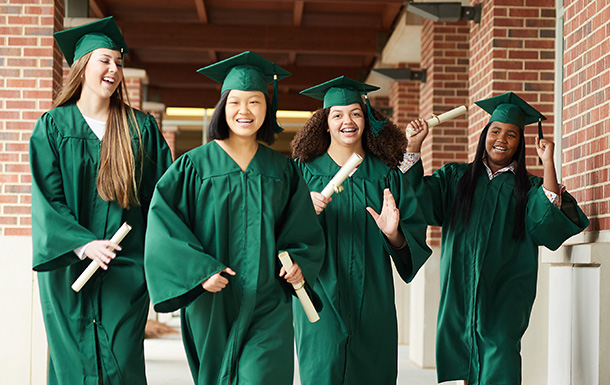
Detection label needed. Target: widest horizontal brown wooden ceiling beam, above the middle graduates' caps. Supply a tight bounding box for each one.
[122,21,380,55]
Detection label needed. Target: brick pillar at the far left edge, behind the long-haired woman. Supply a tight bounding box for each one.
[0,0,64,236]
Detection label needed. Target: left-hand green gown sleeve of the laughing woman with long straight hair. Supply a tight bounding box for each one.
[30,113,96,271]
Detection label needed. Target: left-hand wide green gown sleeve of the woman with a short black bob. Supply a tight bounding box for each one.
[144,156,227,312]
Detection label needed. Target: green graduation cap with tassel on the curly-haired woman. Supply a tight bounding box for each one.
[300,76,386,135]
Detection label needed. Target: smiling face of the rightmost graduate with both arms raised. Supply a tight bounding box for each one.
[485,122,521,172]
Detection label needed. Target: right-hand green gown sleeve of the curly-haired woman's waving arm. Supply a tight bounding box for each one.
[380,170,432,282]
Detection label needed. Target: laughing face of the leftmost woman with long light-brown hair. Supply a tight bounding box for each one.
[82,48,123,99]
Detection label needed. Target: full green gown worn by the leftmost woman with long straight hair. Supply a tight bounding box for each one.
[30,103,171,385]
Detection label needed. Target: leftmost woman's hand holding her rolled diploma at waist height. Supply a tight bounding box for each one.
[72,222,131,293]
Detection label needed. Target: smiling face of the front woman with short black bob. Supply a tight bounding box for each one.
[225,90,267,140]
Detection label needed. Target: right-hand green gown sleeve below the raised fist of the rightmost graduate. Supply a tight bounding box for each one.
[525,185,589,250]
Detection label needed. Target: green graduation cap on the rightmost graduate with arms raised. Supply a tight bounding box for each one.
[475,92,546,139]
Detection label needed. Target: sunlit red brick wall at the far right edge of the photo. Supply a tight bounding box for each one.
[562,0,610,231]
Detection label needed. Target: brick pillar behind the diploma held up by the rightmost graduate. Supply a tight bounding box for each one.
[419,20,470,246]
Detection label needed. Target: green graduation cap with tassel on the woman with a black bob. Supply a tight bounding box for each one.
[197,51,292,132]
